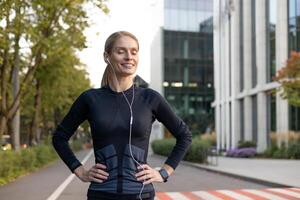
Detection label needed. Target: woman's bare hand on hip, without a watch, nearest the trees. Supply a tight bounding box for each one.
[74,163,109,183]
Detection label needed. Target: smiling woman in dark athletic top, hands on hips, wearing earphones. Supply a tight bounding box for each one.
[53,31,191,200]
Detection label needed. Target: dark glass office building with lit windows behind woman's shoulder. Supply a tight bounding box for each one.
[163,0,214,133]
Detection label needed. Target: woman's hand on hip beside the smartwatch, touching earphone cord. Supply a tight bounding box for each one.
[135,164,164,185]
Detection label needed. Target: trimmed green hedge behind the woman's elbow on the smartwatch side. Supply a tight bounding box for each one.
[151,138,210,163]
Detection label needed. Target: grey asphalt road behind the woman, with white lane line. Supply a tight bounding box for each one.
[0,151,274,200]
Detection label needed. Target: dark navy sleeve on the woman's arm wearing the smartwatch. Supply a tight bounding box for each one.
[154,90,192,169]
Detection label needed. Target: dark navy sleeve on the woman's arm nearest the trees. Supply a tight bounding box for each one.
[52,92,88,173]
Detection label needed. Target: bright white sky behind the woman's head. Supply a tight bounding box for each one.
[78,0,163,88]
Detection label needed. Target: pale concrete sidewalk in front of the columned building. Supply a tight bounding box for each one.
[182,156,300,188]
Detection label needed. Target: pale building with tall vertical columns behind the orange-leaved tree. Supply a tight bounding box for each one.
[212,0,300,151]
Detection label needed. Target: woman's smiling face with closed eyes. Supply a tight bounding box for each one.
[106,36,139,77]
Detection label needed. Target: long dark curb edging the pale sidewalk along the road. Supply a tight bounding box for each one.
[152,153,295,188]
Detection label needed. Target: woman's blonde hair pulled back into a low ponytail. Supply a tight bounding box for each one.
[101,31,139,87]
